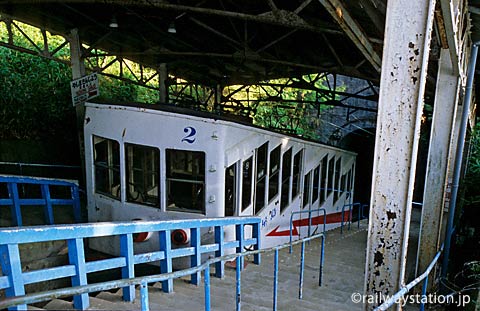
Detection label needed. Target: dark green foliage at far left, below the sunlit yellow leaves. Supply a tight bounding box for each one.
[0,48,75,139]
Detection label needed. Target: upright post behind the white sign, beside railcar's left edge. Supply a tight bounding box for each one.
[69,29,86,185]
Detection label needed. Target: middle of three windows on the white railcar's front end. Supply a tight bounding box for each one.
[125,144,160,207]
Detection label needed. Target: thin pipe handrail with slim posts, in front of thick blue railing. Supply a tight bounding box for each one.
[0,233,325,311]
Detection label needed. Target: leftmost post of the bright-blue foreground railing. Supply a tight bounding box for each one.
[0,244,27,310]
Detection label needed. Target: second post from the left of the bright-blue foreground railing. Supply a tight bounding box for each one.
[67,238,89,310]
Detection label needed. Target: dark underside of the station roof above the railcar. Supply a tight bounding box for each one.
[0,0,480,89]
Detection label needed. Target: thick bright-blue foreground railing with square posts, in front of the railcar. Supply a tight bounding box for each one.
[0,217,260,310]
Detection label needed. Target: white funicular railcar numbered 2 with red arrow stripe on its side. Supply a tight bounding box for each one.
[85,103,356,266]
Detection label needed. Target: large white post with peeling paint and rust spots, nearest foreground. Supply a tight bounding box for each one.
[365,0,435,310]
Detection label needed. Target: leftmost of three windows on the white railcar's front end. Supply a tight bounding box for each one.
[93,136,120,200]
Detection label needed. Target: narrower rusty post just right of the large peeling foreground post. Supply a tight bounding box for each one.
[415,49,458,283]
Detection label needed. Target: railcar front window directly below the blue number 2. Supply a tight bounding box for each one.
[166,149,205,214]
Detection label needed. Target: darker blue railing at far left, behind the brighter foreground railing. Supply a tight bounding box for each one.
[0,175,82,227]
